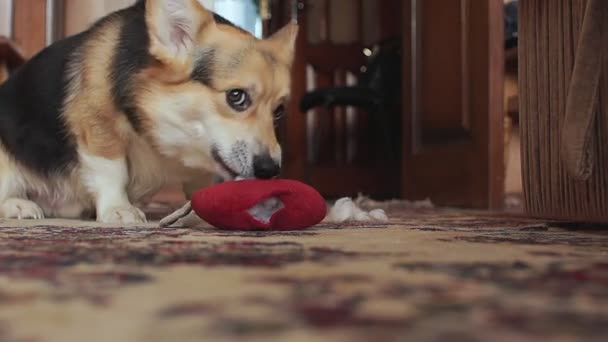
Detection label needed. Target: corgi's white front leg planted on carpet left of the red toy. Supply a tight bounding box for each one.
[80,153,146,224]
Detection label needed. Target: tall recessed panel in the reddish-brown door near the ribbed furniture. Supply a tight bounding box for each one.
[417,0,470,144]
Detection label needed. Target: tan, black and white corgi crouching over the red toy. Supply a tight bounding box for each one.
[0,0,298,224]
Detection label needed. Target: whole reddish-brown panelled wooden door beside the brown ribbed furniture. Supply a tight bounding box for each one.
[402,0,504,209]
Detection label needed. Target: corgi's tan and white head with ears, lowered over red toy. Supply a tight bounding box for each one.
[137,0,298,179]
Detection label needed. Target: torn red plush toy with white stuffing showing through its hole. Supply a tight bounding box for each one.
[191,179,327,230]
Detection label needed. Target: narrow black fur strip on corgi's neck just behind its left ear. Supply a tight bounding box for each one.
[110,1,151,131]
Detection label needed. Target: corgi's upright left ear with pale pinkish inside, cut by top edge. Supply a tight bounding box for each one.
[145,0,215,63]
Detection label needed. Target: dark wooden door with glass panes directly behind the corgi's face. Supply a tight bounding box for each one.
[274,0,401,197]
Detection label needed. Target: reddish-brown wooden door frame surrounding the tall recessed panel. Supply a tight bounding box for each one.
[402,0,505,209]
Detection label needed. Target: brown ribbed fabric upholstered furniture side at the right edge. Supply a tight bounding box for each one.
[519,0,608,223]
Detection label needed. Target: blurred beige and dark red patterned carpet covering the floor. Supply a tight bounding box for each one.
[0,203,608,341]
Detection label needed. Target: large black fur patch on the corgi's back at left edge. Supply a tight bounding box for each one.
[0,33,86,175]
